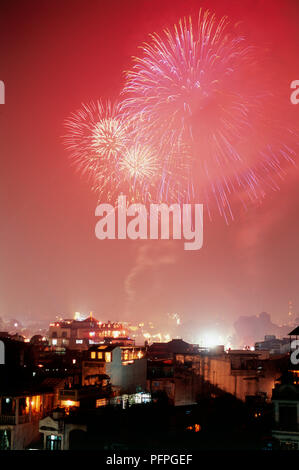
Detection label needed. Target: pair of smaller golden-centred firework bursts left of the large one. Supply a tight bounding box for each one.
[64,101,169,204]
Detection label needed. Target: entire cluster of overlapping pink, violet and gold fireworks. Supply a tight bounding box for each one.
[64,10,297,222]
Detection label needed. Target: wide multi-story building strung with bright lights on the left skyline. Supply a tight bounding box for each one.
[49,315,134,351]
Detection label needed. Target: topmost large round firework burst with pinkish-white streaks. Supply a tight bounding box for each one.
[123,12,254,145]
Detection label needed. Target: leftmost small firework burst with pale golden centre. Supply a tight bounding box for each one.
[64,101,131,201]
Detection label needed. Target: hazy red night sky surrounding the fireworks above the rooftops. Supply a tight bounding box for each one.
[0,0,299,334]
